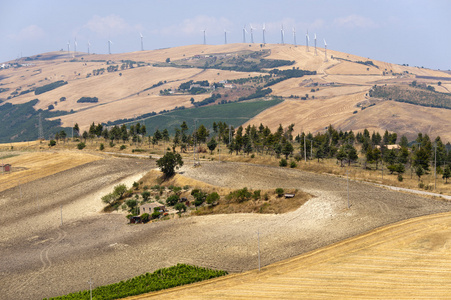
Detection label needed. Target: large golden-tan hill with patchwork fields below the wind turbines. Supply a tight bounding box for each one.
[0,44,451,142]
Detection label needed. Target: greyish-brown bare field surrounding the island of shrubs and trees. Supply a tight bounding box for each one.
[0,159,451,299]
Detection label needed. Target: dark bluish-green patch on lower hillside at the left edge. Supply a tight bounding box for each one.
[0,99,69,143]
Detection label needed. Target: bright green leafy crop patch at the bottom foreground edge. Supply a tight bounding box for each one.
[44,264,228,300]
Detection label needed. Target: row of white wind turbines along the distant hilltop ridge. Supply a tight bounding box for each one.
[67,24,327,61]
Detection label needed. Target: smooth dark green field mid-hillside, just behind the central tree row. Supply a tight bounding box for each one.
[141,99,283,134]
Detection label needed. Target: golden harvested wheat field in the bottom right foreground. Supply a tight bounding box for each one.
[137,213,451,300]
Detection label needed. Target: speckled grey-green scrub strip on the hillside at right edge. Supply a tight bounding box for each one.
[369,85,451,109]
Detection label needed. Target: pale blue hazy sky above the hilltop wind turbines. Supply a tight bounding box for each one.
[0,0,451,70]
